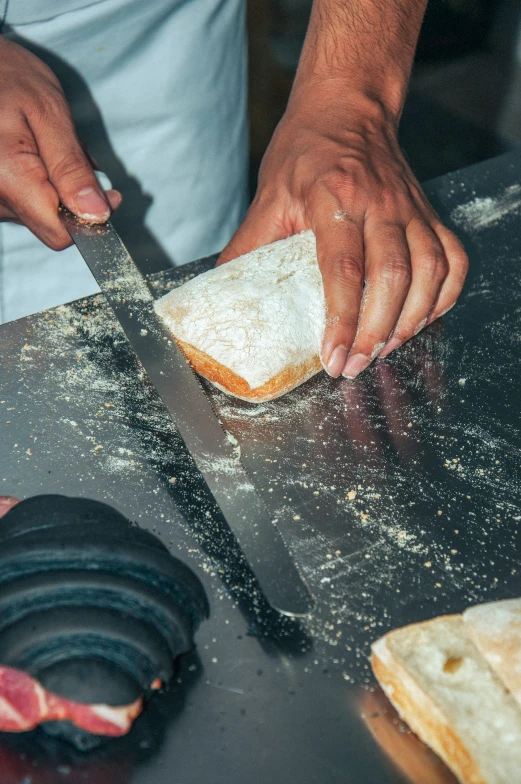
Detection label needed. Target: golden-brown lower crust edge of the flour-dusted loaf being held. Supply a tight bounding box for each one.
[176,339,322,403]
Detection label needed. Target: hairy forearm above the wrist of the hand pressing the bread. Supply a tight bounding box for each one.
[293,0,427,121]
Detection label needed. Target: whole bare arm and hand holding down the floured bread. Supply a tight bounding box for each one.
[219,0,468,377]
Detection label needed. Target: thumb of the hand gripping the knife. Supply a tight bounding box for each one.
[31,98,110,223]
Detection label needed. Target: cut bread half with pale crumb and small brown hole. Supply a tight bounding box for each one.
[372,615,521,784]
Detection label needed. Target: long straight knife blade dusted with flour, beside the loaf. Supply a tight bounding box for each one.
[60,210,314,615]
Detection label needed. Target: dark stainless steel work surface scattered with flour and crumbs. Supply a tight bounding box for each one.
[0,153,521,784]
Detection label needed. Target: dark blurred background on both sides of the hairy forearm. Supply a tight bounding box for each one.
[248,0,521,192]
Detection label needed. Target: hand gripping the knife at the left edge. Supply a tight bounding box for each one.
[0,36,121,250]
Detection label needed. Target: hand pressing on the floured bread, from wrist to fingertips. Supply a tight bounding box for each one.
[219,86,468,378]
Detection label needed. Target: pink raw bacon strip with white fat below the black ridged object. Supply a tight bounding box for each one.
[0,666,143,737]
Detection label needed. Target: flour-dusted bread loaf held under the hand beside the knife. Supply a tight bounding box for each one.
[155,231,325,402]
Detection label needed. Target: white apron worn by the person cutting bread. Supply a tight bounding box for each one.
[0,0,247,322]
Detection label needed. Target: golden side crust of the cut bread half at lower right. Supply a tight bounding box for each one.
[371,628,487,784]
